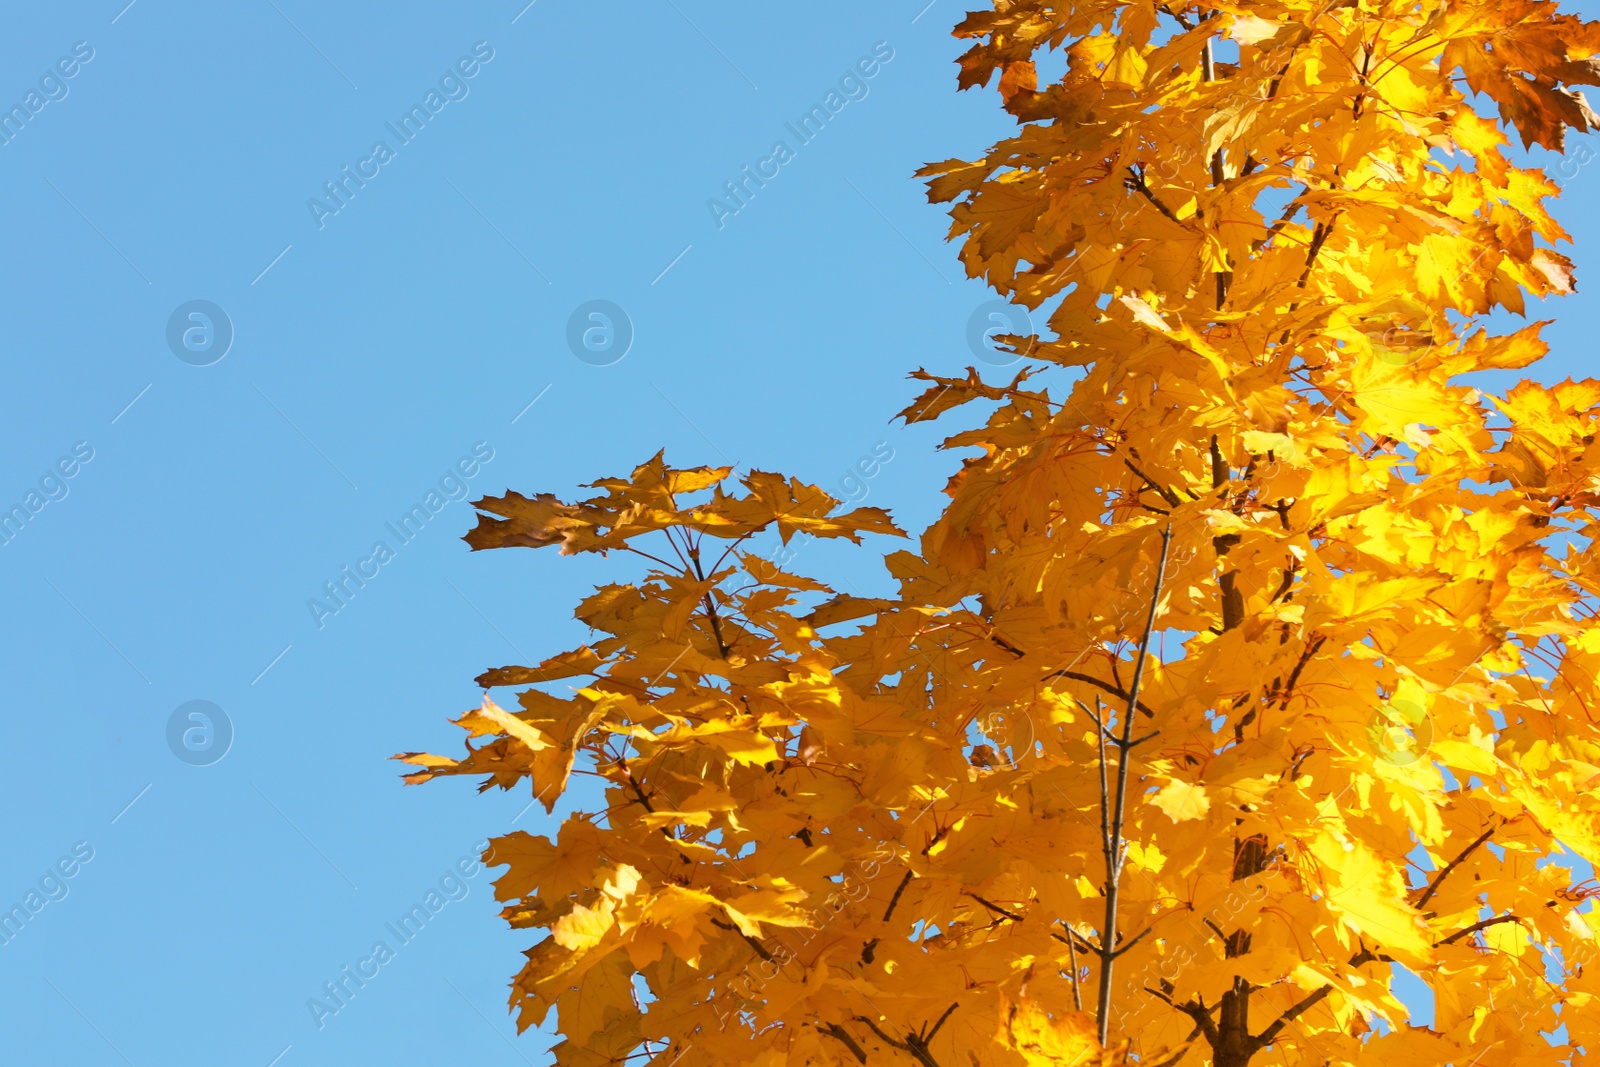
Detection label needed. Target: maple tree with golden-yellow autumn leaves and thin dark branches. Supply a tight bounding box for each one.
[400,0,1600,1067]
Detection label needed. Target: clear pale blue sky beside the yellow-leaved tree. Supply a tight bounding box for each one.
[0,0,1600,1067]
